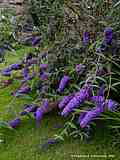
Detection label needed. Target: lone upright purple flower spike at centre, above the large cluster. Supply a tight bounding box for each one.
[57,75,70,92]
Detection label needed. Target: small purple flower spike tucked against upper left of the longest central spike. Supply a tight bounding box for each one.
[58,95,74,109]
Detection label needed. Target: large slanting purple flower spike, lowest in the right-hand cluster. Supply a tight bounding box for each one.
[79,103,104,128]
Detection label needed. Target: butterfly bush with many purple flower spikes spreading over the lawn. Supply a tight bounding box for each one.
[2,14,118,148]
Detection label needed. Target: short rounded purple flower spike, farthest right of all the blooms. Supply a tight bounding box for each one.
[105,99,118,111]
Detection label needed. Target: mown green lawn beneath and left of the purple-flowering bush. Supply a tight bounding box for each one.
[0,48,120,160]
